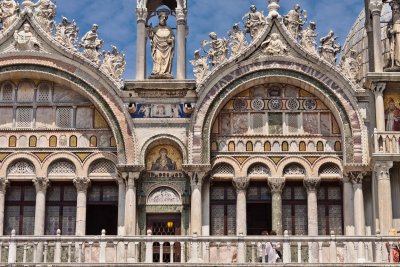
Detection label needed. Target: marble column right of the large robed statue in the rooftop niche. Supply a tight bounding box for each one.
[176,8,187,80]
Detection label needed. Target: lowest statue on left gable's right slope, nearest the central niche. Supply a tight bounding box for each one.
[100,45,126,81]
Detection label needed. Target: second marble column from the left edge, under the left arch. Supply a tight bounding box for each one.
[32,177,50,262]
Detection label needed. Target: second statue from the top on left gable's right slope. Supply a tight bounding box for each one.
[55,17,79,51]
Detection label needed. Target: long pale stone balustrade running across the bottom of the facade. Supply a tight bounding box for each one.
[0,230,400,266]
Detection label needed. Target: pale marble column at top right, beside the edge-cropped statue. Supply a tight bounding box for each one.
[369,0,383,72]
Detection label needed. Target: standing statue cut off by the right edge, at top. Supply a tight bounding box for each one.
[387,1,400,68]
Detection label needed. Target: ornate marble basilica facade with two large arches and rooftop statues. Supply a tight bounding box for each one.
[0,0,400,266]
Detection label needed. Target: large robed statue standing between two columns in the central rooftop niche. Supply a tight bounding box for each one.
[149,10,175,79]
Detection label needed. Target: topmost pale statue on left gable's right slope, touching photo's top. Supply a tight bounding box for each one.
[32,0,56,34]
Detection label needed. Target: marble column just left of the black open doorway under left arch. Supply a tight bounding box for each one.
[73,177,90,236]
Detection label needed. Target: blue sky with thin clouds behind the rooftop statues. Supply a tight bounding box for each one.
[52,0,364,80]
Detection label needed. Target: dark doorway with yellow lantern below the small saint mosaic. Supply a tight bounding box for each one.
[147,213,181,262]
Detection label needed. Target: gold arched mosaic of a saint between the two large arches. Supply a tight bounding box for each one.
[146,145,182,171]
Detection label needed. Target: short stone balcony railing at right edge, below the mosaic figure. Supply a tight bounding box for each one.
[374,130,400,155]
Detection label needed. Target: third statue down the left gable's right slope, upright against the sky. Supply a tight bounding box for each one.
[79,24,103,65]
